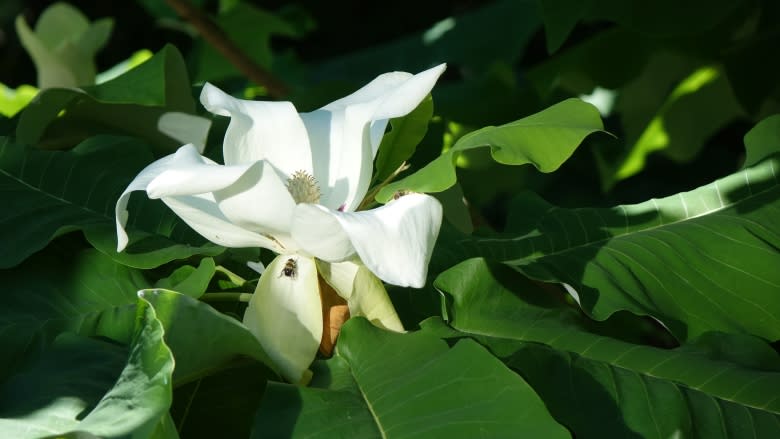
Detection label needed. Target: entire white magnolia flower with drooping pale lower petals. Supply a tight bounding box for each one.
[116,64,445,382]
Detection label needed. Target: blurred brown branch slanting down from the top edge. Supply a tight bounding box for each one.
[166,0,288,99]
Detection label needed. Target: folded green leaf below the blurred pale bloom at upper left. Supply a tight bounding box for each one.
[16,45,204,152]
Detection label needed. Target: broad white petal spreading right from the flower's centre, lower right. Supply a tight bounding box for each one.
[292,194,442,288]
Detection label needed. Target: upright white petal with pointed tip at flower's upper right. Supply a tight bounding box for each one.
[301,64,446,211]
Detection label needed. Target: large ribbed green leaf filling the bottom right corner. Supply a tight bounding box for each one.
[432,259,780,438]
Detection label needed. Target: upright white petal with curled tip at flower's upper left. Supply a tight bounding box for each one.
[200,83,312,176]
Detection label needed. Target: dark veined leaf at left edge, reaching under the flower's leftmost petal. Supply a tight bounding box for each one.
[0,136,222,268]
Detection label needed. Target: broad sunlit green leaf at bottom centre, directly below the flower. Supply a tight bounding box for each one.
[253,318,569,438]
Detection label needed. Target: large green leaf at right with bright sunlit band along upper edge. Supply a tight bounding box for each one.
[454,156,780,340]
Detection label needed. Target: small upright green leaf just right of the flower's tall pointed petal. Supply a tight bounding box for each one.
[374,95,433,183]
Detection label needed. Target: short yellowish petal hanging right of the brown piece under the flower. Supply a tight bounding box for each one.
[317,261,404,332]
